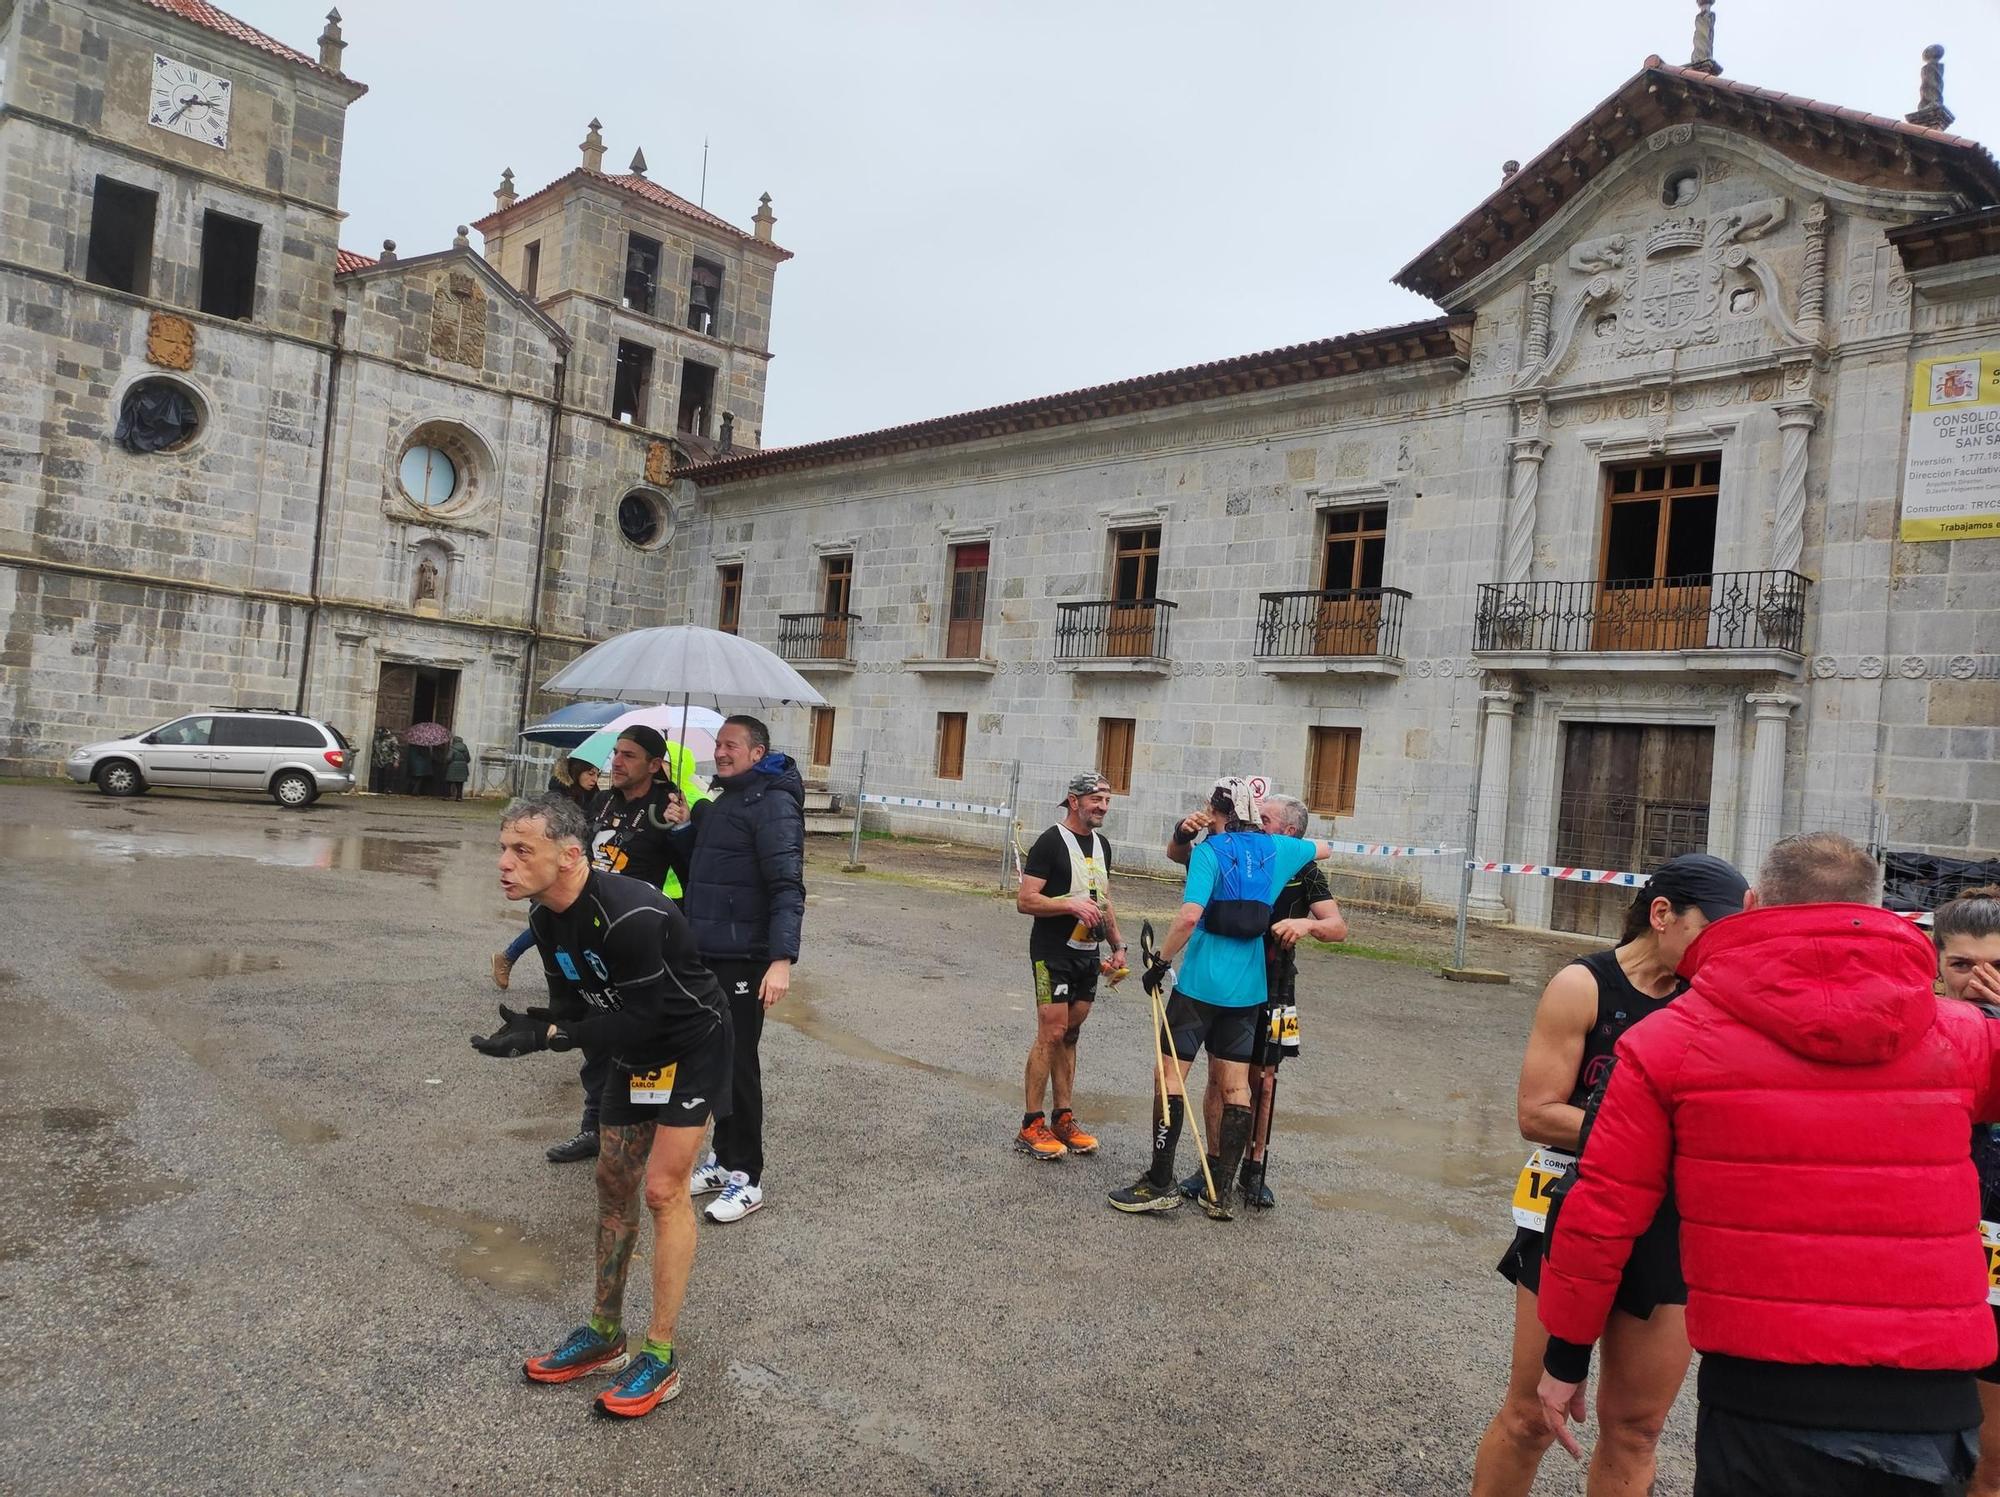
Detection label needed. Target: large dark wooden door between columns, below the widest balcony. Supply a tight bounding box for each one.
[1550,722,1716,939]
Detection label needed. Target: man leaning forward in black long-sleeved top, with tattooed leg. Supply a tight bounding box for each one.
[472,797,730,1419]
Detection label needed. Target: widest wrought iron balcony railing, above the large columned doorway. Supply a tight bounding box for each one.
[1472,572,1812,654]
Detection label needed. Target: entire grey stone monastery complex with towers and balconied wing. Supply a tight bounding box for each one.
[0,0,2000,931]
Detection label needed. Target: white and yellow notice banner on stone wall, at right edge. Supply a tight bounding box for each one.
[1902,350,2000,540]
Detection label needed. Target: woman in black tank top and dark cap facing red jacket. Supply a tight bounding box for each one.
[1472,853,1748,1497]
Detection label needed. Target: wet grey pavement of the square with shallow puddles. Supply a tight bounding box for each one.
[0,787,1692,1495]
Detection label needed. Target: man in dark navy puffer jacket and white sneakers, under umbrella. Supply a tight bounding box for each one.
[670,716,806,1223]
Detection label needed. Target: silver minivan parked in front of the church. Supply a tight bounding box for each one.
[68,706,354,809]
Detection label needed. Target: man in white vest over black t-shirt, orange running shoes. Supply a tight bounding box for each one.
[1014,771,1124,1159]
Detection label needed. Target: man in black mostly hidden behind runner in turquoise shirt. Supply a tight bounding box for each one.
[1166,795,1348,1211]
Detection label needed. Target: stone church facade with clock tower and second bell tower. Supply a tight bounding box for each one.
[0,0,788,789]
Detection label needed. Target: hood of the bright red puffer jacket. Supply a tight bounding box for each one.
[1680,905,1938,1065]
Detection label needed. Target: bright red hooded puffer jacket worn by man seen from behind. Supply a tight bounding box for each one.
[1540,905,2000,1371]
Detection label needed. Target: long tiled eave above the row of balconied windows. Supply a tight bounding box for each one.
[676,314,1472,482]
